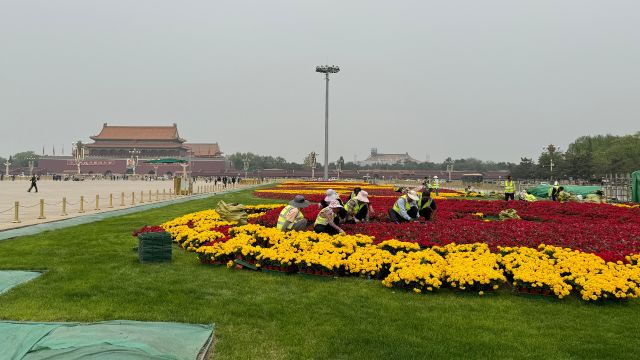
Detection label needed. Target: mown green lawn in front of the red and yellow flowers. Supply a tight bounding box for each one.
[0,192,640,359]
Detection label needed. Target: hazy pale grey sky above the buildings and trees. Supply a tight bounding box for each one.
[0,0,640,162]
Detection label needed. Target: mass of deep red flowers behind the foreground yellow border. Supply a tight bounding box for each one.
[255,197,640,261]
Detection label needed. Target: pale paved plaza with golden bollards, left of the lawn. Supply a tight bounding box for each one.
[0,180,236,231]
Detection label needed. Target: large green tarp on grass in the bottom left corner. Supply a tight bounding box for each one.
[0,320,214,360]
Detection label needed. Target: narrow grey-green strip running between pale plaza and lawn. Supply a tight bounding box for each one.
[0,184,265,241]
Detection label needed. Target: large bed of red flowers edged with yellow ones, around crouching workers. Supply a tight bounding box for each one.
[142,183,640,301]
